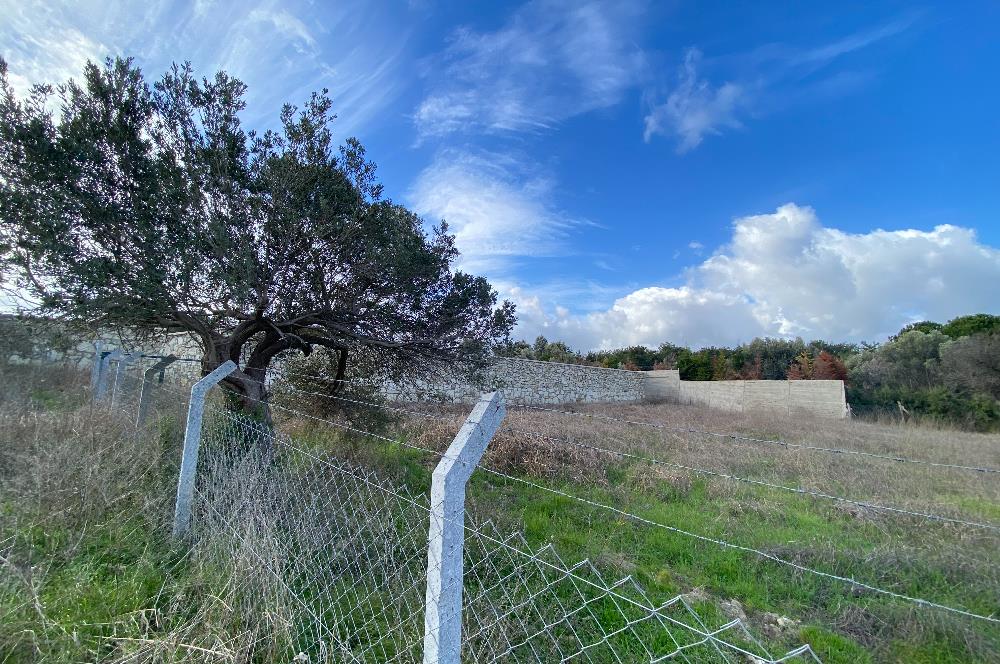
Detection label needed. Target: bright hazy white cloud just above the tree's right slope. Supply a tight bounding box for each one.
[407,150,576,275]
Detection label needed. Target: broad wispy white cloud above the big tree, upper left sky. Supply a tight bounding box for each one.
[0,0,407,136]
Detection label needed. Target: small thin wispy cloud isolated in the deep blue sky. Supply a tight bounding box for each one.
[643,48,746,153]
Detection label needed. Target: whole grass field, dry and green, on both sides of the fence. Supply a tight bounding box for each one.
[0,370,1000,662]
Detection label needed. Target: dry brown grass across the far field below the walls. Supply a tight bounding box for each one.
[392,394,1000,524]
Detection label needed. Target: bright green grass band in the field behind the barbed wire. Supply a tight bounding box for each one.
[298,422,1000,663]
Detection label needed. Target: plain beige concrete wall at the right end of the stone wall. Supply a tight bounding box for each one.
[646,370,847,418]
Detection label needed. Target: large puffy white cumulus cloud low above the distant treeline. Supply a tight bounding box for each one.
[508,203,1000,348]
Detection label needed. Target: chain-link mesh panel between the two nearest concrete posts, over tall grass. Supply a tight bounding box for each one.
[193,409,428,662]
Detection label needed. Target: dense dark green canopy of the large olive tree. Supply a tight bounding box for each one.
[0,59,515,412]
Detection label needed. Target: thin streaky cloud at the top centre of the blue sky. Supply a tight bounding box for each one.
[414,0,642,138]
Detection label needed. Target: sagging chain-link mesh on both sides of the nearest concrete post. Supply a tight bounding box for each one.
[174,396,818,663]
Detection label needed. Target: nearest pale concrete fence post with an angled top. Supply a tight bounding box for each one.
[424,392,506,664]
